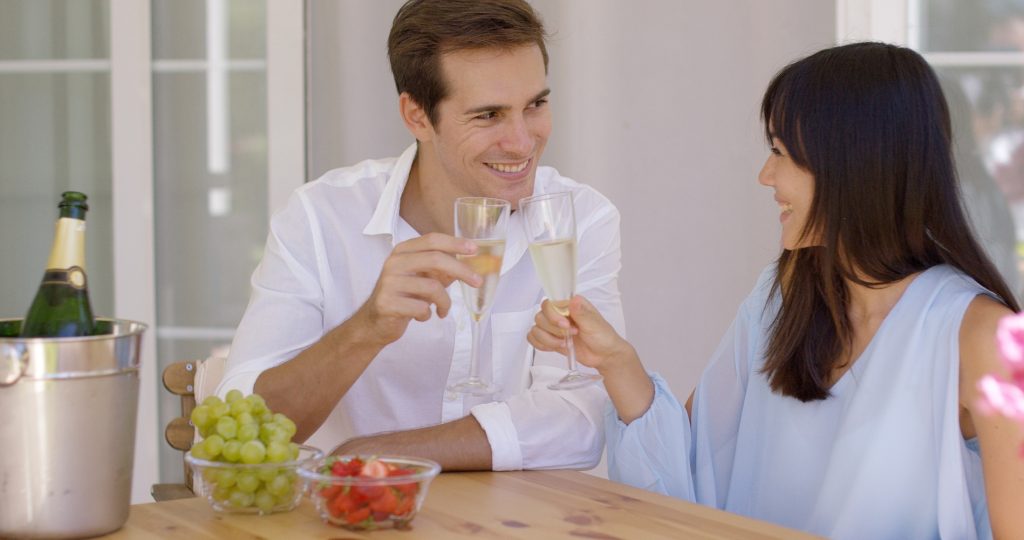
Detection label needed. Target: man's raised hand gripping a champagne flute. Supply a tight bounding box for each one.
[352,233,483,347]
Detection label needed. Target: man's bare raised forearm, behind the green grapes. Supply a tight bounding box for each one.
[254,314,382,442]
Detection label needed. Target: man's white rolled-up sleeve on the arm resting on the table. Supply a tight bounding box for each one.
[471,190,626,470]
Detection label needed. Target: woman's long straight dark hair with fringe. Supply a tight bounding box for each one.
[761,43,1019,402]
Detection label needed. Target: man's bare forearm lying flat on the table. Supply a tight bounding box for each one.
[334,415,492,470]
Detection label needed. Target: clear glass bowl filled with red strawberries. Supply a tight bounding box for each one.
[299,456,441,531]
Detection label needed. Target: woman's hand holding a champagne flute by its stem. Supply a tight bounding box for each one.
[526,296,635,372]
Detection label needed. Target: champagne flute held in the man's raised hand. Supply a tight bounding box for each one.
[447,197,512,396]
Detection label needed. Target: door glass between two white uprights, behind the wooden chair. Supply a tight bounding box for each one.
[153,0,268,482]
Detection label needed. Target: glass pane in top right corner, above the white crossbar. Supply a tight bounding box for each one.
[920,0,1024,52]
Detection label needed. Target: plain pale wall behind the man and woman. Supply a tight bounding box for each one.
[309,0,836,405]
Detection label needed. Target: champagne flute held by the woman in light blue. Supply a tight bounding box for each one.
[519,192,601,390]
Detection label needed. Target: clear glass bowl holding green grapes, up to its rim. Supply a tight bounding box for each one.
[185,446,324,515]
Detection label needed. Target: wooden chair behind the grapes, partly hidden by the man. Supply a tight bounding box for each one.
[151,357,226,501]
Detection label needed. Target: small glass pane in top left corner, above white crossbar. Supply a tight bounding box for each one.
[0,0,111,60]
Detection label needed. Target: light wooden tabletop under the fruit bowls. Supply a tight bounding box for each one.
[104,470,815,540]
